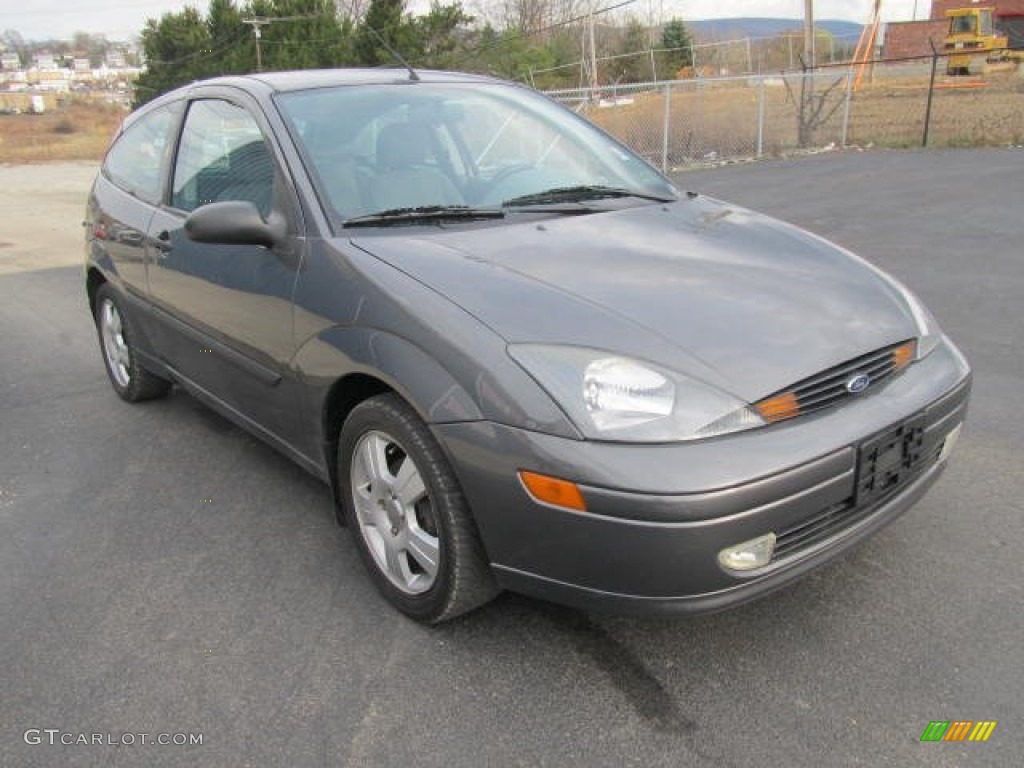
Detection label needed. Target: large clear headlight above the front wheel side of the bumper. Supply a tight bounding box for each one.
[508,344,765,442]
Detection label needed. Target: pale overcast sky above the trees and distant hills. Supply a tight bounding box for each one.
[0,0,931,40]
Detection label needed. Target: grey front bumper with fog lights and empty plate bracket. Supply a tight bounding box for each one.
[434,341,970,614]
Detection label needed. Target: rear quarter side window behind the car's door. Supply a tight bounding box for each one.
[103,106,174,204]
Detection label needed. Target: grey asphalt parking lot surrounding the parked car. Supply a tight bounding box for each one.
[6,150,1024,768]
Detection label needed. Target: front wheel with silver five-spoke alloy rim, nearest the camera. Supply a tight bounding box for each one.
[338,394,499,624]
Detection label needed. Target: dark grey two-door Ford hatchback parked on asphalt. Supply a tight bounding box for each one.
[85,70,970,623]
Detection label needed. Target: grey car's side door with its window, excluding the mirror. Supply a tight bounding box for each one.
[147,97,301,441]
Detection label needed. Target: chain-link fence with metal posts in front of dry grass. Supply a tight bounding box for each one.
[547,57,1024,172]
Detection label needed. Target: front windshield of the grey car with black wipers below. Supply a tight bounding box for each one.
[279,83,676,222]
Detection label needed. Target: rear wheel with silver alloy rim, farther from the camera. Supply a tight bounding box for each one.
[94,283,171,402]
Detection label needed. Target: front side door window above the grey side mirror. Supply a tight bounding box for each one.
[171,99,274,217]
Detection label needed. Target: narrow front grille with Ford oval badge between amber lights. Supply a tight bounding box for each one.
[755,341,914,422]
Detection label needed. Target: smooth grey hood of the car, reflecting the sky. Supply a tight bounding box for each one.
[351,197,918,401]
